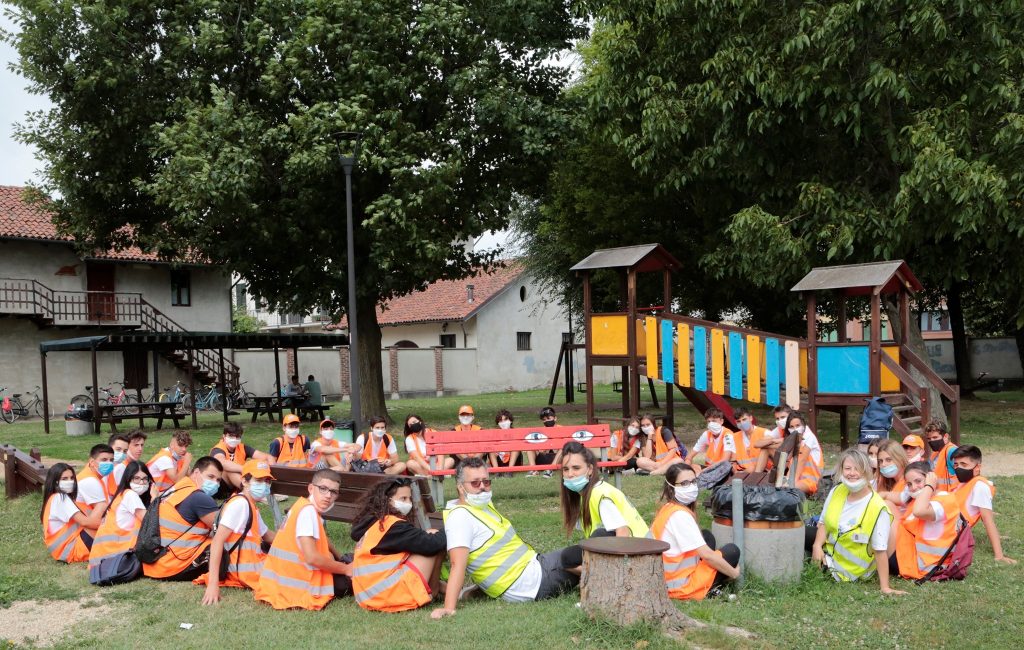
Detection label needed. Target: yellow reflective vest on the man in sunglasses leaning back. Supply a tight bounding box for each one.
[442,504,537,598]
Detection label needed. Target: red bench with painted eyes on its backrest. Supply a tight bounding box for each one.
[424,424,626,501]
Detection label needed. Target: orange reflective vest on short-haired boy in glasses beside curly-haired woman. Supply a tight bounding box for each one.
[253,496,334,609]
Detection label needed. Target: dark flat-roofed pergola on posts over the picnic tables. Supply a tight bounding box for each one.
[39,332,348,433]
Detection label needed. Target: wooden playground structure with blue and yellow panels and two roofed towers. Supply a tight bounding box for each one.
[571,244,959,447]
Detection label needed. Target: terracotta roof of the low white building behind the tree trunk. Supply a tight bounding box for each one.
[324,261,525,330]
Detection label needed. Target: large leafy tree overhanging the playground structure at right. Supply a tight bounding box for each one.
[532,0,1024,405]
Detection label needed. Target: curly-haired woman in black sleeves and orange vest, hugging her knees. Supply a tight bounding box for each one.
[351,478,447,612]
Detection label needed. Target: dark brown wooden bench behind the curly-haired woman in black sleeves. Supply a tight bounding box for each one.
[268,465,444,530]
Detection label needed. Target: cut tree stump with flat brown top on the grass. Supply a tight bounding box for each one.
[580,537,680,625]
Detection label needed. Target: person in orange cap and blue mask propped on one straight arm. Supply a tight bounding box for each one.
[194,459,274,605]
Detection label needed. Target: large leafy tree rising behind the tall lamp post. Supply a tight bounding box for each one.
[5,0,581,416]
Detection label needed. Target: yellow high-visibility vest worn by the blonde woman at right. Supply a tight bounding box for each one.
[823,483,892,582]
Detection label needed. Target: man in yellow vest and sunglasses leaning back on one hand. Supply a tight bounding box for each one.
[430,458,583,619]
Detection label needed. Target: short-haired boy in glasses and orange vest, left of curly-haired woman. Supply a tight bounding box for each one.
[253,470,352,610]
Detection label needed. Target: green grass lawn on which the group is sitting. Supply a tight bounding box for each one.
[0,389,1024,649]
